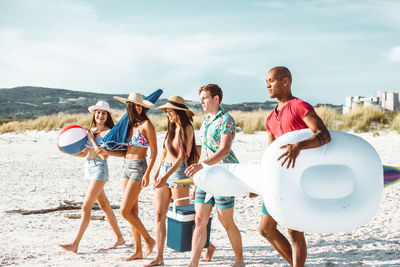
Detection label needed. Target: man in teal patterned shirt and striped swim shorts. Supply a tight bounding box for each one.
[186,84,245,267]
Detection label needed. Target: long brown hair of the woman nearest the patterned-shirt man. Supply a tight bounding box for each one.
[164,109,199,165]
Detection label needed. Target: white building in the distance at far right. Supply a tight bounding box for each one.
[343,91,400,113]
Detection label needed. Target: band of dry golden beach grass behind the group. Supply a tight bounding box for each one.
[0,106,400,134]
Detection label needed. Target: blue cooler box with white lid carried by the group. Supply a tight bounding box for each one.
[167,203,212,252]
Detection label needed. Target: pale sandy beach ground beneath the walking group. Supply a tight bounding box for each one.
[0,131,400,266]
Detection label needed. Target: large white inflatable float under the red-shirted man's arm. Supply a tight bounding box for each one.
[194,129,383,233]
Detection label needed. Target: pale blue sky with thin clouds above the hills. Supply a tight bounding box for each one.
[0,0,400,105]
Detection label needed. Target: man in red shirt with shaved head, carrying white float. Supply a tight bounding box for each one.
[259,66,331,266]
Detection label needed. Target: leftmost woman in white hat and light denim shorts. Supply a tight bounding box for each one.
[59,101,125,253]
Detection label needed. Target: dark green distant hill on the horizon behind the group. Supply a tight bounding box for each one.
[0,86,282,119]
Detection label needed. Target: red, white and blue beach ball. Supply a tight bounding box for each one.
[57,125,88,154]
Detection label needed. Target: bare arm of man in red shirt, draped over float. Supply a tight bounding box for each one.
[278,111,331,168]
